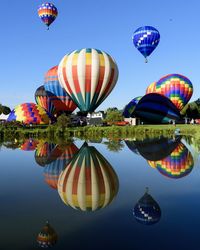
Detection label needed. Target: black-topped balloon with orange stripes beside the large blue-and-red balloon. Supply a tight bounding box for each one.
[35,86,55,115]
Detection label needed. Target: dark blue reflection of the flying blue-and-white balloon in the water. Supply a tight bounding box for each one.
[133,188,161,225]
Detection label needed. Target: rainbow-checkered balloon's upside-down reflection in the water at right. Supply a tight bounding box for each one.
[148,142,194,179]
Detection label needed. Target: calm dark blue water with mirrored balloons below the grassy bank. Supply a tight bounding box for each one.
[0,138,200,250]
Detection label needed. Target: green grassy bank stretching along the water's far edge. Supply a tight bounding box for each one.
[0,124,200,140]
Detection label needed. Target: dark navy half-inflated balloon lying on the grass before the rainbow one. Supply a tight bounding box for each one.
[133,93,180,124]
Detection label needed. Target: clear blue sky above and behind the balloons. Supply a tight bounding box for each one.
[0,0,200,110]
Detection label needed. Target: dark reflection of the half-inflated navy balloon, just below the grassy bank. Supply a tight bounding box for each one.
[132,136,181,161]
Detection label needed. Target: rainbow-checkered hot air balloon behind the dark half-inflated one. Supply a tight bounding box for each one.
[156,74,193,110]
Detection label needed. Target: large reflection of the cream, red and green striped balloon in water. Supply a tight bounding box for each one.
[58,143,119,211]
